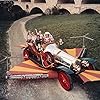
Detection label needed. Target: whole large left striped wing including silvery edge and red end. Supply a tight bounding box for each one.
[7,60,58,79]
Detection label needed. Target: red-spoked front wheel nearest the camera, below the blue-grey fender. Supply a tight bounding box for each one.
[58,71,73,91]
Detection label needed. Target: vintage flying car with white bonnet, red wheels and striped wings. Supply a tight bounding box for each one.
[7,43,100,91]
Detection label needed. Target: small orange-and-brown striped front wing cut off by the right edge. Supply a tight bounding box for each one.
[79,70,100,83]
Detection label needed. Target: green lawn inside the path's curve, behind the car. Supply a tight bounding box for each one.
[26,14,100,69]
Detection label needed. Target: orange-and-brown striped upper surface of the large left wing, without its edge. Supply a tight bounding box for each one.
[9,60,48,74]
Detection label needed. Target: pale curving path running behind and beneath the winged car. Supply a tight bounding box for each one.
[6,15,89,100]
